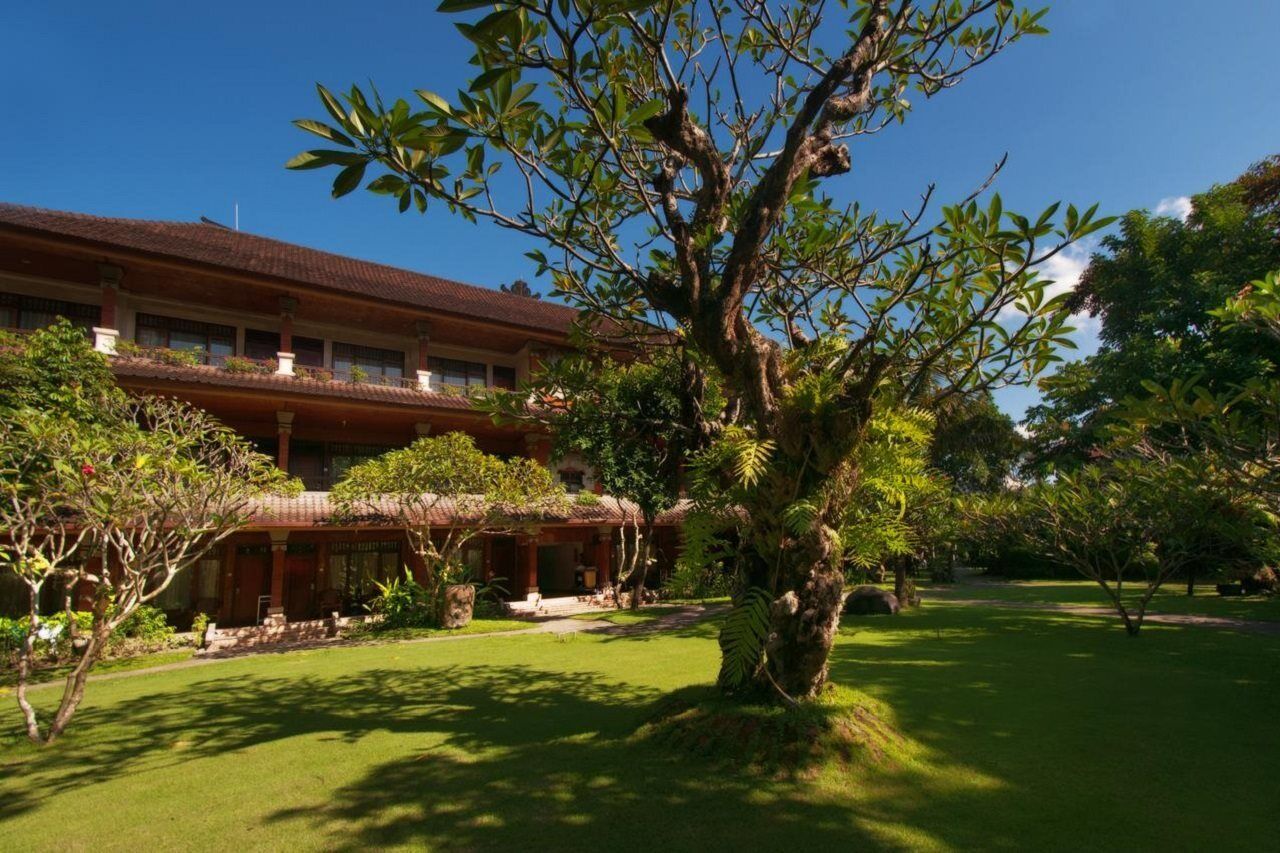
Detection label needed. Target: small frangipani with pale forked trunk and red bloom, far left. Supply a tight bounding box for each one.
[0,398,289,743]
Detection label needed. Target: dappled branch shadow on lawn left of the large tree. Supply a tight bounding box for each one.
[0,653,947,850]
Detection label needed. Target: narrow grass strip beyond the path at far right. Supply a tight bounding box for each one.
[922,580,1280,621]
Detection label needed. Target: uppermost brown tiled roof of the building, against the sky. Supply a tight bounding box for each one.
[0,202,577,333]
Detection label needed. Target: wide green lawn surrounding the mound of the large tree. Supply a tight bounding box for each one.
[0,602,1280,852]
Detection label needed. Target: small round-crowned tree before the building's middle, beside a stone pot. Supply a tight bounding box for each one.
[330,433,567,617]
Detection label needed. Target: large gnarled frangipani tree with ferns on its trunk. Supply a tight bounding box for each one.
[289,0,1106,697]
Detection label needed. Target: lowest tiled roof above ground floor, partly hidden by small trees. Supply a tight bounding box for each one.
[251,492,687,528]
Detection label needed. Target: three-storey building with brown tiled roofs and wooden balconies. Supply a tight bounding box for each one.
[0,204,676,626]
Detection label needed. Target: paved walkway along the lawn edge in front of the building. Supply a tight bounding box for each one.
[17,596,724,693]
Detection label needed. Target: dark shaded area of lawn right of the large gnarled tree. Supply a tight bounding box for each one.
[831,607,1280,849]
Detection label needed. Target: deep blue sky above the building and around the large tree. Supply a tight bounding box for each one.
[0,0,1280,416]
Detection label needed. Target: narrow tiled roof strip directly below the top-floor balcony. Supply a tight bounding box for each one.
[111,357,481,410]
